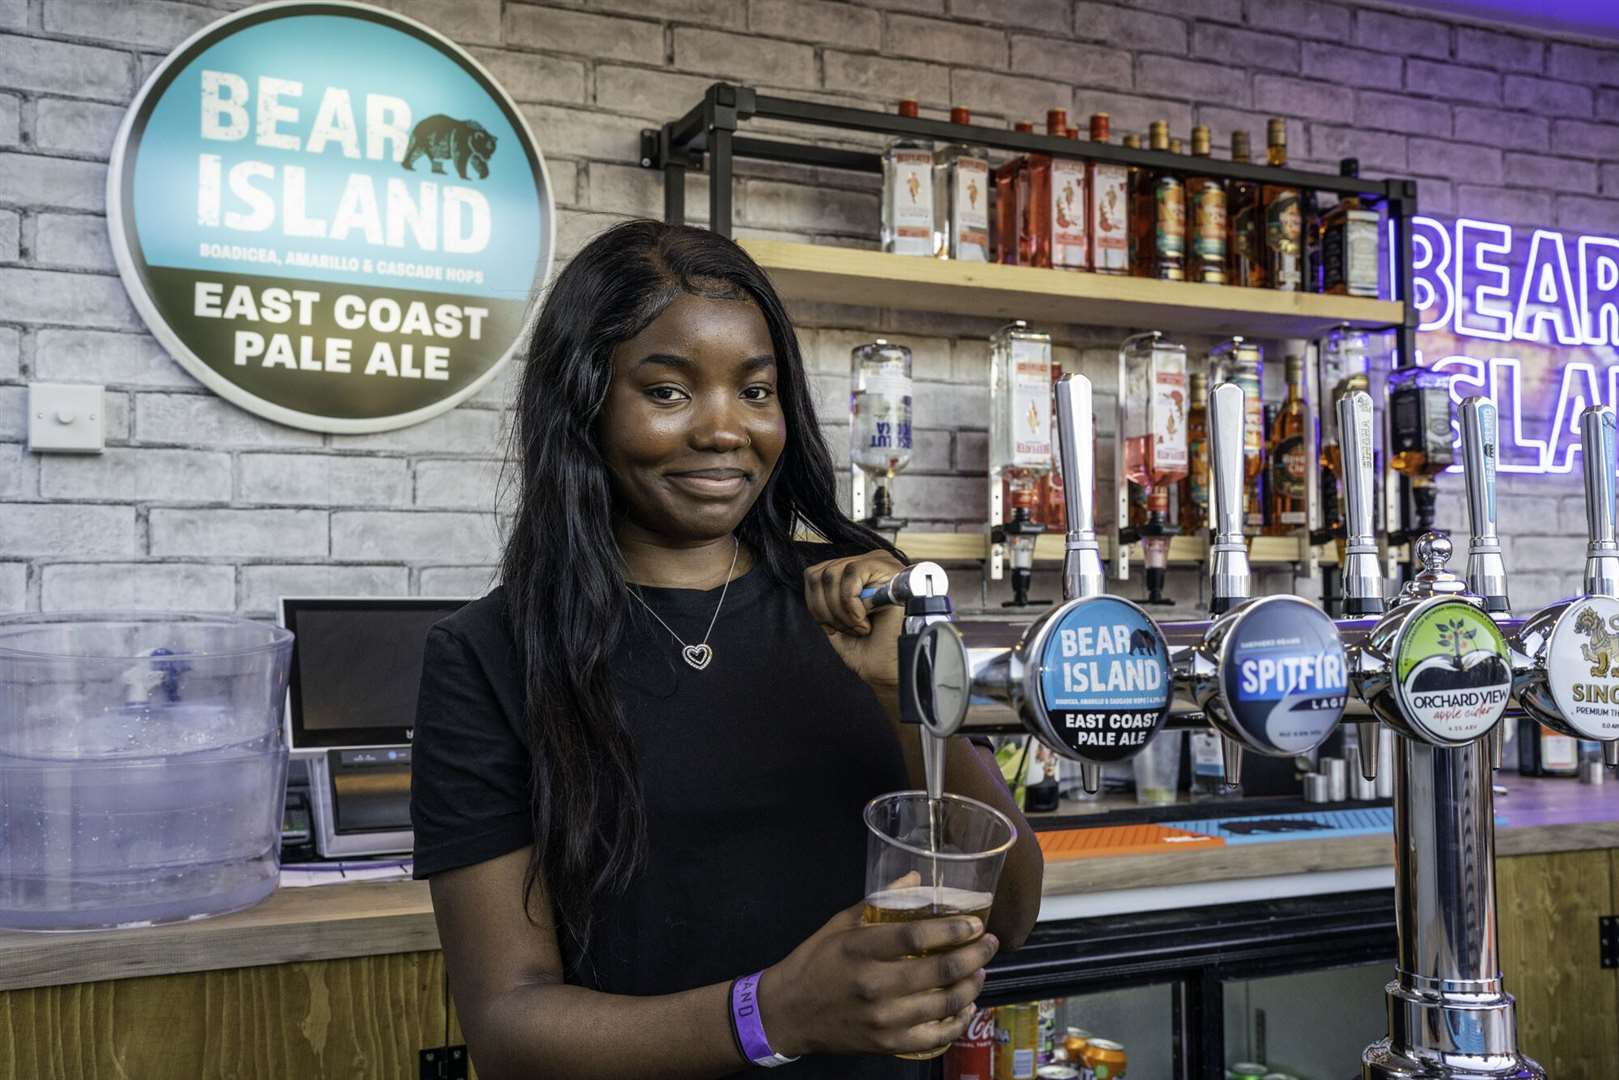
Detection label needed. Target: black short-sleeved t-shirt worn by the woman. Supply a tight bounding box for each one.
[411,550,918,1080]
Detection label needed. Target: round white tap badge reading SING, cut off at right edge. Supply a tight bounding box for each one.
[1546,596,1619,738]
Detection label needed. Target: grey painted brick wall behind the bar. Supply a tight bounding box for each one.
[0,0,1619,615]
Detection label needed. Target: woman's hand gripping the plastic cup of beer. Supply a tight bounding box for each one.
[759,904,1001,1057]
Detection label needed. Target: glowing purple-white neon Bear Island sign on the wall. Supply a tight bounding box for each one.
[1389,217,1619,473]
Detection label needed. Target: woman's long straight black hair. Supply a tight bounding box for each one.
[502,220,897,957]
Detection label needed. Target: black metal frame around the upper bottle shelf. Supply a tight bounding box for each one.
[641,83,1418,553]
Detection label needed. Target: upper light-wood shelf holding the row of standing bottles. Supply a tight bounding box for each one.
[740,240,1405,338]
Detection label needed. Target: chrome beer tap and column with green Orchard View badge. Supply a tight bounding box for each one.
[1350,398,1545,1080]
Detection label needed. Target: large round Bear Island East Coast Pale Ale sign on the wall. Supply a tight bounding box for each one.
[107,2,555,432]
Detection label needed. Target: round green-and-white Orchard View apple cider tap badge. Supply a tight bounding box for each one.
[1394,599,1512,746]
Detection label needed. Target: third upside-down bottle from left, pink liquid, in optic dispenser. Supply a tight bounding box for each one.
[1124,334,1187,604]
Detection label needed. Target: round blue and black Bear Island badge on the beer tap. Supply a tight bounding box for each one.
[1039,596,1174,761]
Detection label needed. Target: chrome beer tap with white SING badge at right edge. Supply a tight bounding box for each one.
[1515,405,1619,766]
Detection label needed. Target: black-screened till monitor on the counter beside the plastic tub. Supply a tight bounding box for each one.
[280,596,466,858]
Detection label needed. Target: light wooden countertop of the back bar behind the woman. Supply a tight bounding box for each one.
[0,774,1619,997]
